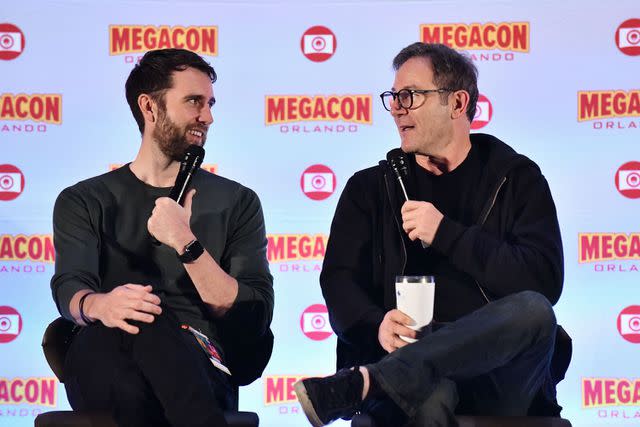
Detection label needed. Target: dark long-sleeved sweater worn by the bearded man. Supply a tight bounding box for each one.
[51,165,273,382]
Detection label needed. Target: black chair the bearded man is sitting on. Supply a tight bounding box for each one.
[35,317,260,427]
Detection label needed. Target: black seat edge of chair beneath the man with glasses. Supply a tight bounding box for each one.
[351,414,571,427]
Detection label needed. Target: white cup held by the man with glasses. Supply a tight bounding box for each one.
[396,276,436,343]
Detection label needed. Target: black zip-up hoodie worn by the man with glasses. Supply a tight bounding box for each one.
[320,134,563,374]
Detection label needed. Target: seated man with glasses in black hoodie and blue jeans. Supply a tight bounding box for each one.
[295,43,568,426]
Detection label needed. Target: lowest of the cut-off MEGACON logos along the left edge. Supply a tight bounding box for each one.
[0,377,58,408]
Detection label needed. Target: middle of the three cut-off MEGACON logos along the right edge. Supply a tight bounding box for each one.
[578,233,640,273]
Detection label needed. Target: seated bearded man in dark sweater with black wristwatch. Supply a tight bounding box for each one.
[51,49,273,426]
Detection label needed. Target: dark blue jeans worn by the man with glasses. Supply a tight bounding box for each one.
[365,291,556,426]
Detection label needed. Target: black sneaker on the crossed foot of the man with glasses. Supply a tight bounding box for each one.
[293,367,364,427]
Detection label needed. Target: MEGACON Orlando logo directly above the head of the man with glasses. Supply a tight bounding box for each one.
[420,22,530,61]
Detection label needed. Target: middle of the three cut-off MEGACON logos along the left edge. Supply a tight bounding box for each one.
[0,234,56,273]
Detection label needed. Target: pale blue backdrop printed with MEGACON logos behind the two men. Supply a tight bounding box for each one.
[0,0,640,427]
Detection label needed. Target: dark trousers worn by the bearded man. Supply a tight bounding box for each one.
[64,307,237,427]
